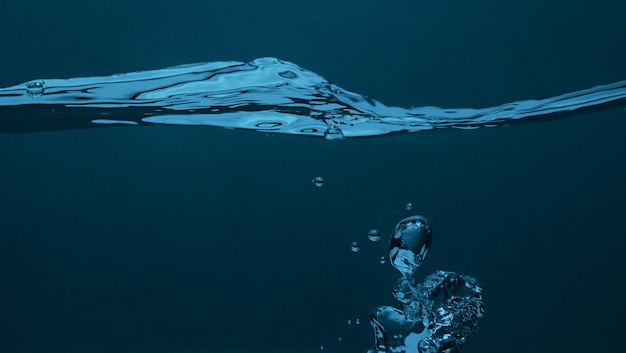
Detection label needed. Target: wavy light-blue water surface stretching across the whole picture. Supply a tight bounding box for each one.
[0,58,626,139]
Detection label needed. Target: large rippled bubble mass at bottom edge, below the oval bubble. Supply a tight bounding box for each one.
[369,271,485,353]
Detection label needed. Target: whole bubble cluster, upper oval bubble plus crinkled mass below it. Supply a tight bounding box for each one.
[368,216,485,353]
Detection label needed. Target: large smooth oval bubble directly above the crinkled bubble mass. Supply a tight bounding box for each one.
[389,216,432,276]
